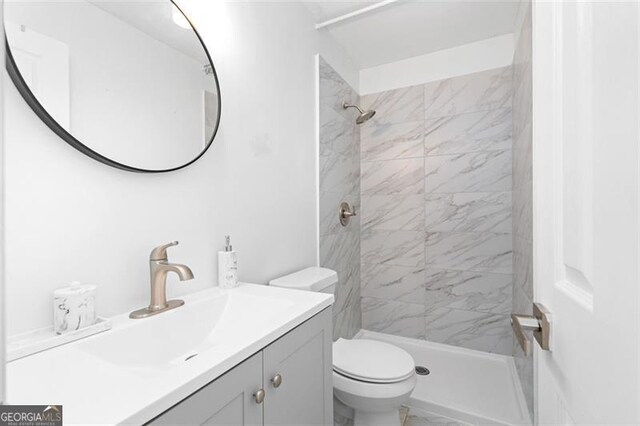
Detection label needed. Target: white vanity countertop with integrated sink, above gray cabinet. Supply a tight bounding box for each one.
[7,284,333,425]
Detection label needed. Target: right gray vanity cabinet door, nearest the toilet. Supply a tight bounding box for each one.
[263,308,333,426]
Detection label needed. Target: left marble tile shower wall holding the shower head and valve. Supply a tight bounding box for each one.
[319,58,362,340]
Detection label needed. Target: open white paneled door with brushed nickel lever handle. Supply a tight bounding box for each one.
[533,0,640,425]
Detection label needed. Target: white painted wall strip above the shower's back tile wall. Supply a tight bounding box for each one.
[360,34,514,95]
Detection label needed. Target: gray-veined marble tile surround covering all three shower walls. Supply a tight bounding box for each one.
[319,39,533,410]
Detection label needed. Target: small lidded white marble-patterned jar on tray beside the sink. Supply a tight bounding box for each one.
[53,281,96,334]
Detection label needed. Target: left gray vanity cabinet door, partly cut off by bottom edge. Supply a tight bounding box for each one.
[148,352,262,426]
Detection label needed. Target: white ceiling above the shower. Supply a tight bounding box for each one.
[303,0,520,69]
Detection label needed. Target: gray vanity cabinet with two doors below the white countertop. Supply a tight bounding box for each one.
[148,308,333,426]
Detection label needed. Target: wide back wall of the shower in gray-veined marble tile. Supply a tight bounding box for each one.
[360,67,513,354]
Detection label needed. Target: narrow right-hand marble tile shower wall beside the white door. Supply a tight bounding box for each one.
[512,3,533,413]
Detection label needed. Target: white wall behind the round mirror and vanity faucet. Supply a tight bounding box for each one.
[4,0,357,334]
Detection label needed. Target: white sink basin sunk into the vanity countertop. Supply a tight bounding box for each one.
[80,290,292,370]
